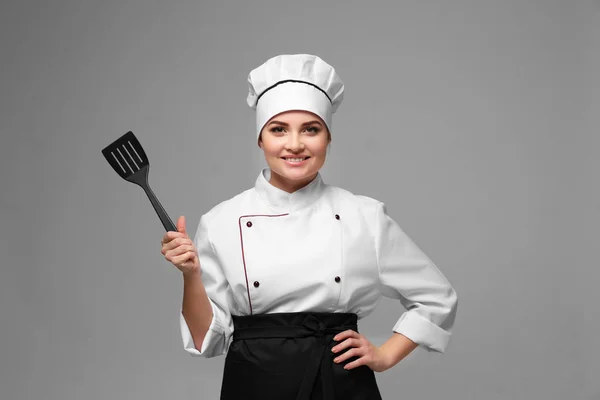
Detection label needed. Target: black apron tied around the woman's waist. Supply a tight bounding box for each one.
[221,312,381,400]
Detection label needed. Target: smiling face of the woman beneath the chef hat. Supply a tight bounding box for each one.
[258,110,331,193]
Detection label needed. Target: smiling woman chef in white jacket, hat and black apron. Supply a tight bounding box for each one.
[161,54,457,400]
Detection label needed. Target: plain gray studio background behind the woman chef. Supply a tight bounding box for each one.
[0,0,600,400]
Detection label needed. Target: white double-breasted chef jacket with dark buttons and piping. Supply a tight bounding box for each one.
[180,168,458,358]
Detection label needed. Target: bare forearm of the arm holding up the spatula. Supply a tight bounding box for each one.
[181,271,213,350]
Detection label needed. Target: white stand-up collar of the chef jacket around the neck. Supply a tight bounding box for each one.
[254,167,325,212]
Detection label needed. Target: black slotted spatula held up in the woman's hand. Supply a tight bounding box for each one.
[102,131,177,232]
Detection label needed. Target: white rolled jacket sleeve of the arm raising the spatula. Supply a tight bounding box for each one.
[179,215,233,358]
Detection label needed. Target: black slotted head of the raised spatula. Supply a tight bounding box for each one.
[102,131,149,185]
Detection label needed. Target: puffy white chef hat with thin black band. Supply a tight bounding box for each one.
[247,54,344,139]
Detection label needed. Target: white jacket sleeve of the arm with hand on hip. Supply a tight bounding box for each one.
[375,202,458,353]
